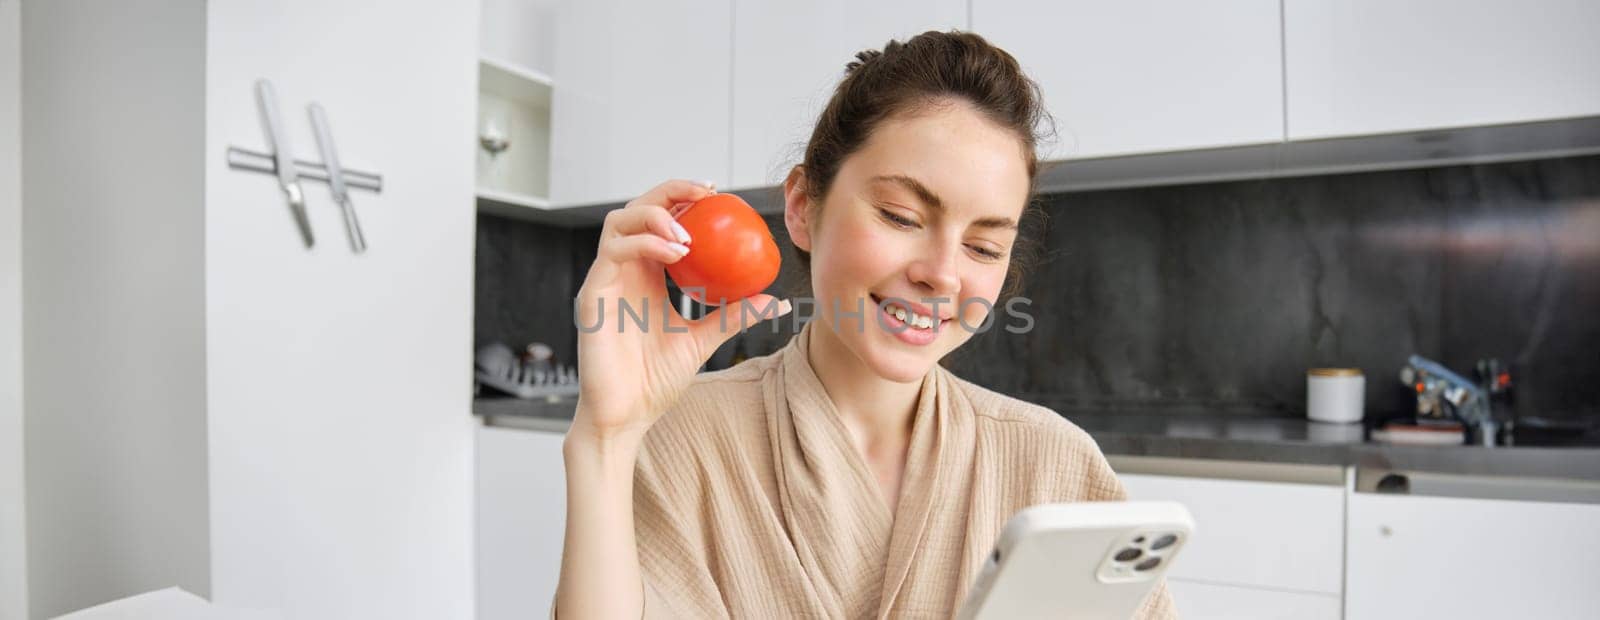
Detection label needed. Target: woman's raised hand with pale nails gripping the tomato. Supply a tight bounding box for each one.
[573,181,789,438]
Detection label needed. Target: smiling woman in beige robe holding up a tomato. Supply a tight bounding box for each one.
[557,32,1173,618]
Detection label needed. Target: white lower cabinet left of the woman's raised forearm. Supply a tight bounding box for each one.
[477,427,566,620]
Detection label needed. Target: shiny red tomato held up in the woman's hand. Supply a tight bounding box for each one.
[667,193,781,305]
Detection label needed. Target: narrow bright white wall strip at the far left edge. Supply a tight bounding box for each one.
[0,0,27,620]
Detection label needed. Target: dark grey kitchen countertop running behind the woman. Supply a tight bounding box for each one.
[472,398,1600,481]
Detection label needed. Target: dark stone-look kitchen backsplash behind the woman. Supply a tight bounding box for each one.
[475,157,1600,417]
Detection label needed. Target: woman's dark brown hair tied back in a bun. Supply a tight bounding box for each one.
[794,30,1053,297]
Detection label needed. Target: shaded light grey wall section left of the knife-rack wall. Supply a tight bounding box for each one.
[22,0,211,617]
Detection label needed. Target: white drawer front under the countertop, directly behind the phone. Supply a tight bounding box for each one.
[1114,462,1344,596]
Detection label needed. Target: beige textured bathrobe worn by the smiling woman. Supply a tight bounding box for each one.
[634,324,1176,618]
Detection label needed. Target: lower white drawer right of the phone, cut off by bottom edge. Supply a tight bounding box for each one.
[1166,577,1341,620]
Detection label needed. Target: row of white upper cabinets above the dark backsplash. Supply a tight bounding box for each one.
[518,0,1600,214]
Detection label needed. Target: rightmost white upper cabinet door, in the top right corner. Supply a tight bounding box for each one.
[1283,0,1600,139]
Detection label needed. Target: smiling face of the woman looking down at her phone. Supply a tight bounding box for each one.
[786,102,1030,382]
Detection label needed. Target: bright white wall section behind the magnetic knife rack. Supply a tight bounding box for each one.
[205,0,478,618]
